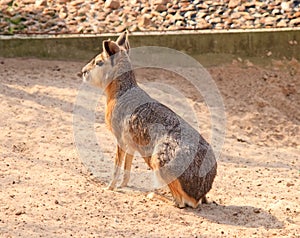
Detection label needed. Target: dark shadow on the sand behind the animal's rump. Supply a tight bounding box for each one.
[186,202,284,229]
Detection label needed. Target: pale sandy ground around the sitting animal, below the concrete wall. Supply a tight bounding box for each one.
[0,56,300,237]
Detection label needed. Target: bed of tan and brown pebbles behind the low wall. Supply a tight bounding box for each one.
[0,0,300,35]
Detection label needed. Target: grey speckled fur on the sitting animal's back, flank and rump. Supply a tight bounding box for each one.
[112,83,217,201]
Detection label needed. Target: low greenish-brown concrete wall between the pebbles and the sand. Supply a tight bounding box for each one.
[0,28,300,61]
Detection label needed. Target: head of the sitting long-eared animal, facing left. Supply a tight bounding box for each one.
[81,31,131,89]
